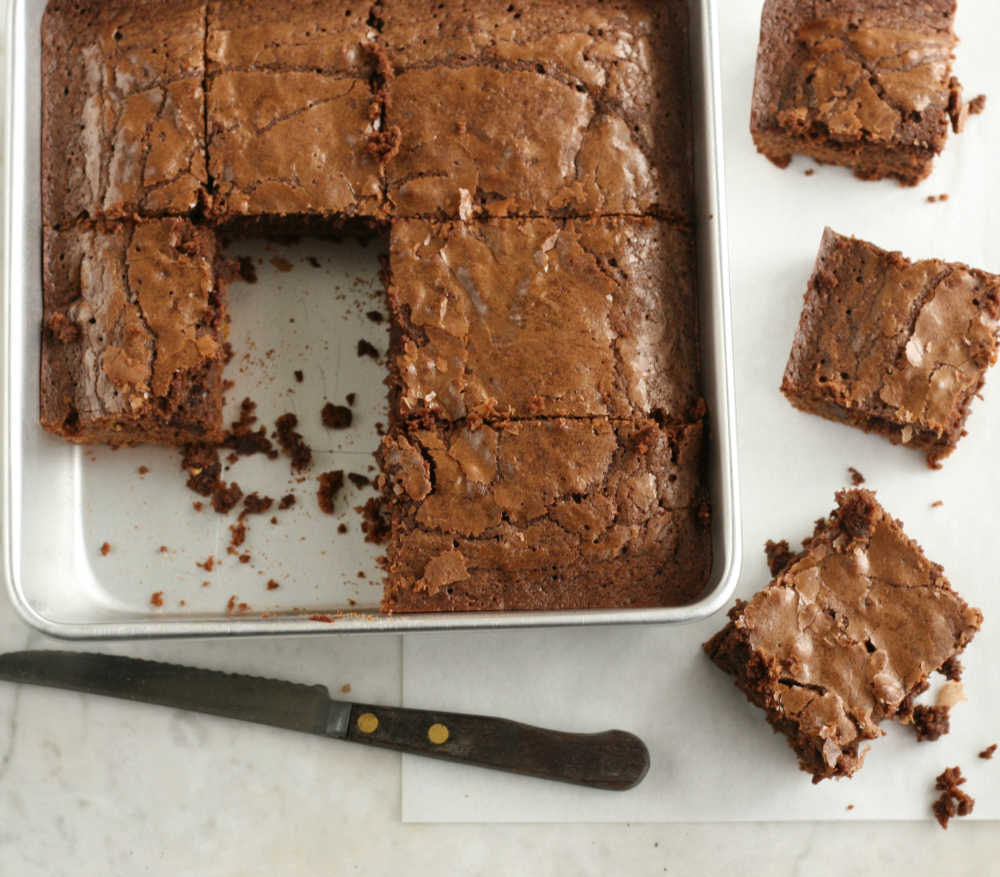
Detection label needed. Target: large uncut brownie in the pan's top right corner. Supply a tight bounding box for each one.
[381,0,691,218]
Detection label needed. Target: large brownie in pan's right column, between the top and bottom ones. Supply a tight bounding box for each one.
[389,217,699,423]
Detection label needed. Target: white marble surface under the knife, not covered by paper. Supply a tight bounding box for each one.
[0,0,1000,877]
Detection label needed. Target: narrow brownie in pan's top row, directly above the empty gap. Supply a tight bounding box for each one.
[207,0,382,222]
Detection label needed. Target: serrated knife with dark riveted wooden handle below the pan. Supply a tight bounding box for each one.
[0,651,649,791]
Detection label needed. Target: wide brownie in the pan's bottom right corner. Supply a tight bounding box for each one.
[380,419,711,612]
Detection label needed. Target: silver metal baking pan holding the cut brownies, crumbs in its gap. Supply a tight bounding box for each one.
[0,0,741,639]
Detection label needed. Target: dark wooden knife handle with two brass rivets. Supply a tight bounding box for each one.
[347,704,649,791]
